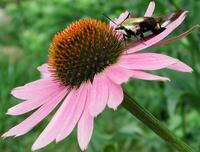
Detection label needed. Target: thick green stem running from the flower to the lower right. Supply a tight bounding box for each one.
[122,93,193,152]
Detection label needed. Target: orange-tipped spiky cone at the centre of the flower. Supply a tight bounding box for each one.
[48,19,123,87]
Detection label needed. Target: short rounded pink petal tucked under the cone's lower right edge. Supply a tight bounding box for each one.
[105,65,132,84]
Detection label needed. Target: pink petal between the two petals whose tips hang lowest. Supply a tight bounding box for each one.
[56,84,88,142]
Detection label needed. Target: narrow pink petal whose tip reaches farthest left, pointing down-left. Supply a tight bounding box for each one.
[3,86,67,137]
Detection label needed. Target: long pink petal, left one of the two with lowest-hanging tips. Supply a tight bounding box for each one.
[32,90,76,151]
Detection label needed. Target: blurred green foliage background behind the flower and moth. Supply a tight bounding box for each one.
[0,0,200,152]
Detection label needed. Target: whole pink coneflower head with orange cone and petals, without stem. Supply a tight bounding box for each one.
[3,2,192,150]
